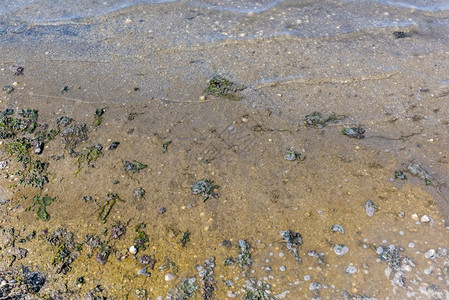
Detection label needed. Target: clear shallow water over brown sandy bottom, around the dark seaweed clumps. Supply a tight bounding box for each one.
[0,1,449,299]
